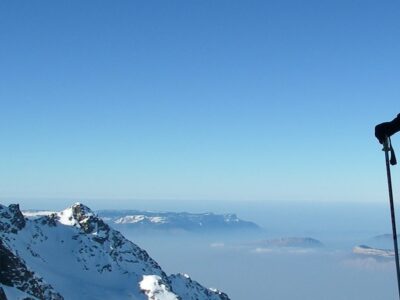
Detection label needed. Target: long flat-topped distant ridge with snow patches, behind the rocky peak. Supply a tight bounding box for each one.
[98,210,261,232]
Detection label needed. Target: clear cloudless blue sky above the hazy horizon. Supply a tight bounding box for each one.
[0,0,400,205]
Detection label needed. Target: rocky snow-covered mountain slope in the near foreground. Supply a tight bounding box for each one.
[0,203,229,300]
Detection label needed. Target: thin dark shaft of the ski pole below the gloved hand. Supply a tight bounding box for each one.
[383,138,400,299]
